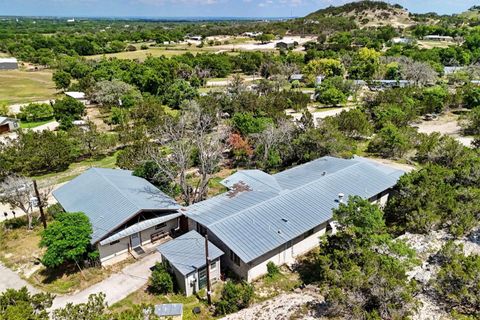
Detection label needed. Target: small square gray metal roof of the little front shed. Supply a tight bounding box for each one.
[157,230,223,276]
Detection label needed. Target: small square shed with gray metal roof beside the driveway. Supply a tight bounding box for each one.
[157,231,223,296]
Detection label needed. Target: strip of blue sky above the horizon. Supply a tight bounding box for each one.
[0,0,479,17]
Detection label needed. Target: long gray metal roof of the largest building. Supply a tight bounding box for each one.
[186,157,404,263]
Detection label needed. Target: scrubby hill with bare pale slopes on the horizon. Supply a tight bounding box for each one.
[305,1,415,28]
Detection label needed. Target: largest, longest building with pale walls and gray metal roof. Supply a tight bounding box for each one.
[185,157,404,281]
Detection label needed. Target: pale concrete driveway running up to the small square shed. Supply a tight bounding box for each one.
[52,251,161,309]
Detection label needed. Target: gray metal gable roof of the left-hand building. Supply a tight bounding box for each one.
[53,168,180,243]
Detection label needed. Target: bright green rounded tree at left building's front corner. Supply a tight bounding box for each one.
[40,212,93,268]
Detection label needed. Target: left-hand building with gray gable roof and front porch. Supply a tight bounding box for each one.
[53,168,182,265]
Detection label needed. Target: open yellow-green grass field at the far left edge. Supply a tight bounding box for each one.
[0,70,56,105]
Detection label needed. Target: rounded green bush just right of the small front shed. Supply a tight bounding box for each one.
[215,281,253,315]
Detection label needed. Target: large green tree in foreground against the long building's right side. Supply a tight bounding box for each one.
[300,197,417,319]
